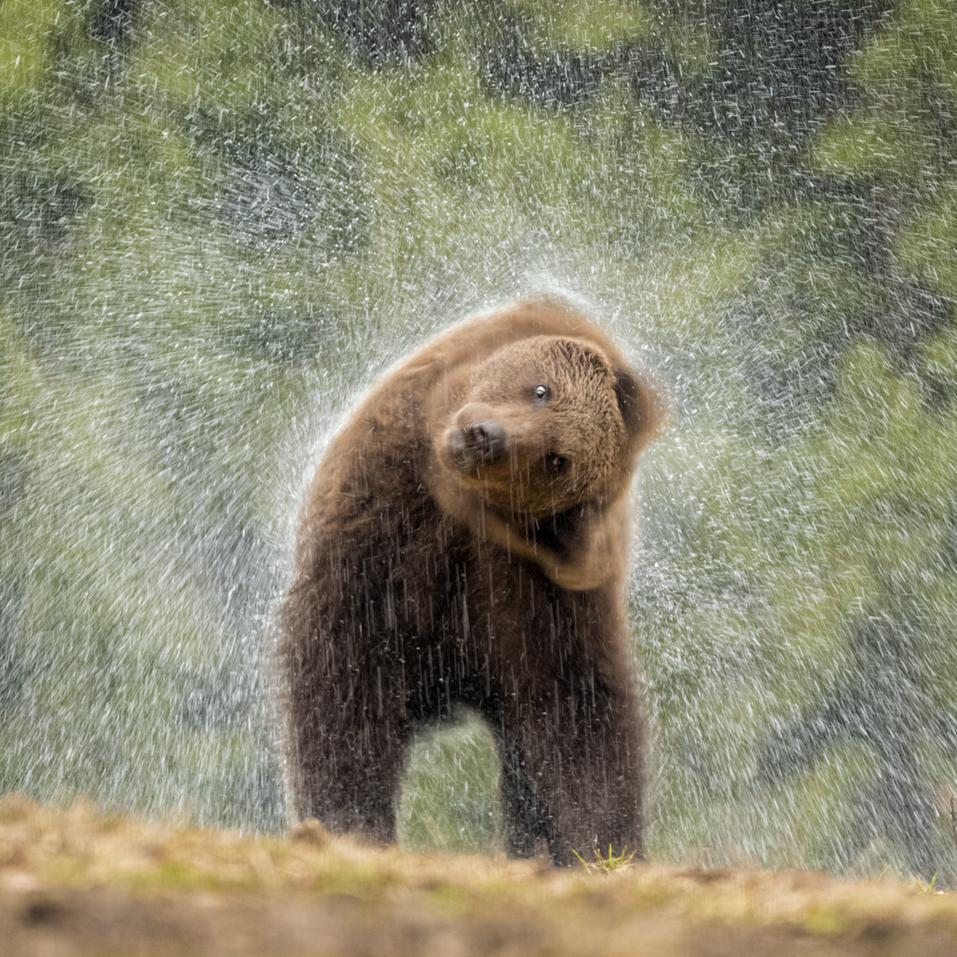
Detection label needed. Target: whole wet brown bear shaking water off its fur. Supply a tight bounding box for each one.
[280,299,657,864]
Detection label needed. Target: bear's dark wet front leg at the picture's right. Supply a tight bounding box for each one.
[503,675,643,866]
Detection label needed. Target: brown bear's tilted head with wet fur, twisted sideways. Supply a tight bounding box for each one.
[433,335,655,518]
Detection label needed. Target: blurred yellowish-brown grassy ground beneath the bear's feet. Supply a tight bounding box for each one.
[0,797,957,957]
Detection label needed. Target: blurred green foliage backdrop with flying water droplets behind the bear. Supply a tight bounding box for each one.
[0,0,957,879]
